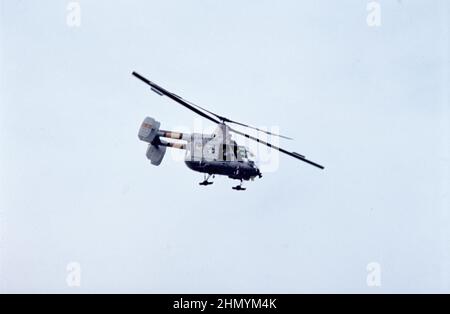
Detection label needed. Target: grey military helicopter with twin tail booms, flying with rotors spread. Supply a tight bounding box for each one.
[132,72,324,191]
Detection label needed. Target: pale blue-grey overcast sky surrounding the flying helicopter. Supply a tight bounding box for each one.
[0,0,450,293]
